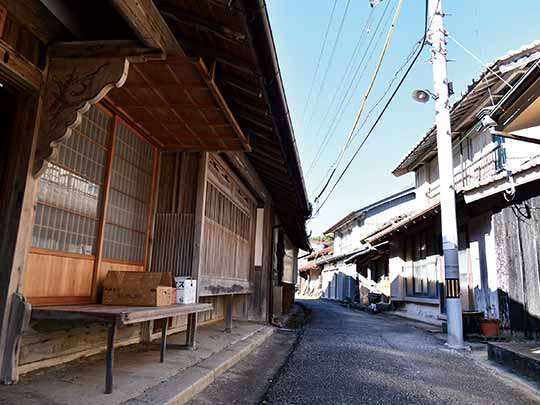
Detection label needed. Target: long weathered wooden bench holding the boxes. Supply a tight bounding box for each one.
[32,304,213,394]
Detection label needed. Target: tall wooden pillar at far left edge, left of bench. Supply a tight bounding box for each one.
[0,93,41,384]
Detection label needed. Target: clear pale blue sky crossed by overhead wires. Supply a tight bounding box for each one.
[267,0,540,235]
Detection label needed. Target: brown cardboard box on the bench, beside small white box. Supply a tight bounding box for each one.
[103,271,176,307]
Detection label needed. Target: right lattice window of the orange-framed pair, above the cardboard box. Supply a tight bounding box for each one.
[103,123,154,263]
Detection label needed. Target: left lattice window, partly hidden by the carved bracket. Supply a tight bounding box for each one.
[32,107,112,255]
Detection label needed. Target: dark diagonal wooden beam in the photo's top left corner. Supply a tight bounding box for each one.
[0,0,69,44]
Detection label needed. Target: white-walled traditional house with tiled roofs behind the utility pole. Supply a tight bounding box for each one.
[367,42,540,332]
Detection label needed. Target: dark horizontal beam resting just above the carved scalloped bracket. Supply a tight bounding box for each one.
[48,40,165,63]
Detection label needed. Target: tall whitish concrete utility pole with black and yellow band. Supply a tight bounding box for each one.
[428,0,463,349]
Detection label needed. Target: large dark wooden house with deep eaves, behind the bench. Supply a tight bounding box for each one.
[0,0,310,383]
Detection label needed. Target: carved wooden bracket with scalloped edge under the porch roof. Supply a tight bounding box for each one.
[33,57,129,177]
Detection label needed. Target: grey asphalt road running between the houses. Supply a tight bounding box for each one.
[260,301,540,405]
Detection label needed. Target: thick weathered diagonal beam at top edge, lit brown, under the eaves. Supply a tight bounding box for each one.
[111,0,185,56]
